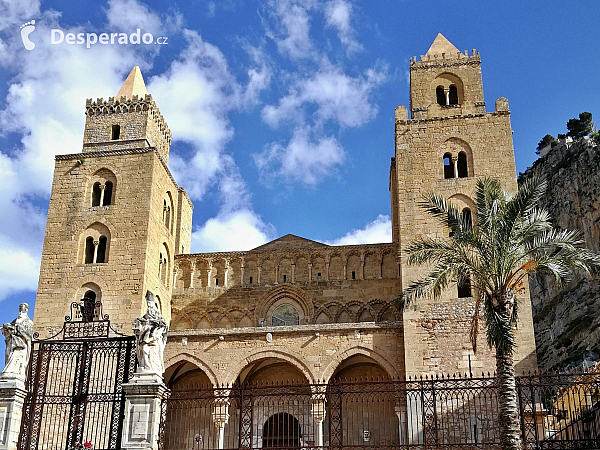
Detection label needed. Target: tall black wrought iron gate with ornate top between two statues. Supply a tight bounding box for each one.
[18,299,135,450]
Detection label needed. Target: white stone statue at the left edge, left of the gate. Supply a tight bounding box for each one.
[1,303,33,380]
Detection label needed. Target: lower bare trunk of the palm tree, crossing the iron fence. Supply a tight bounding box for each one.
[496,350,522,450]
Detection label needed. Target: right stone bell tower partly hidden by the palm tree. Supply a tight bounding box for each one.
[390,34,536,376]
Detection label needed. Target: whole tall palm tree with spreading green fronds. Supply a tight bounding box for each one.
[401,176,600,450]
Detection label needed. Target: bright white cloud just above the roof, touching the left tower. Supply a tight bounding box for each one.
[192,209,275,252]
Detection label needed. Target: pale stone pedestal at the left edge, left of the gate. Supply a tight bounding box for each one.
[0,374,27,450]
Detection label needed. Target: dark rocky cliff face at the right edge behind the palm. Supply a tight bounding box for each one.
[519,139,600,369]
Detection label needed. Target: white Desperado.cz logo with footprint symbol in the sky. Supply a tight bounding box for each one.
[21,20,169,50]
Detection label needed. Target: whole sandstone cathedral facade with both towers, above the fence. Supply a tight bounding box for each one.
[34,35,537,387]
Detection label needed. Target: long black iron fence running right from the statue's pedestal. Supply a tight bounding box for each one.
[159,374,600,450]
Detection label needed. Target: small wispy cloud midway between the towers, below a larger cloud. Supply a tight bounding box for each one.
[253,127,345,185]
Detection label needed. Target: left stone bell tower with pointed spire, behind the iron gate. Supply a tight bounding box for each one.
[34,66,193,337]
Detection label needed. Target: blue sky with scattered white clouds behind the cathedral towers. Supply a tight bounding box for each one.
[0,0,600,344]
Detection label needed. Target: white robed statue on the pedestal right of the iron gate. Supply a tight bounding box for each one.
[133,291,169,376]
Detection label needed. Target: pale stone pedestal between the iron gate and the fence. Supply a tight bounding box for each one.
[120,373,167,450]
